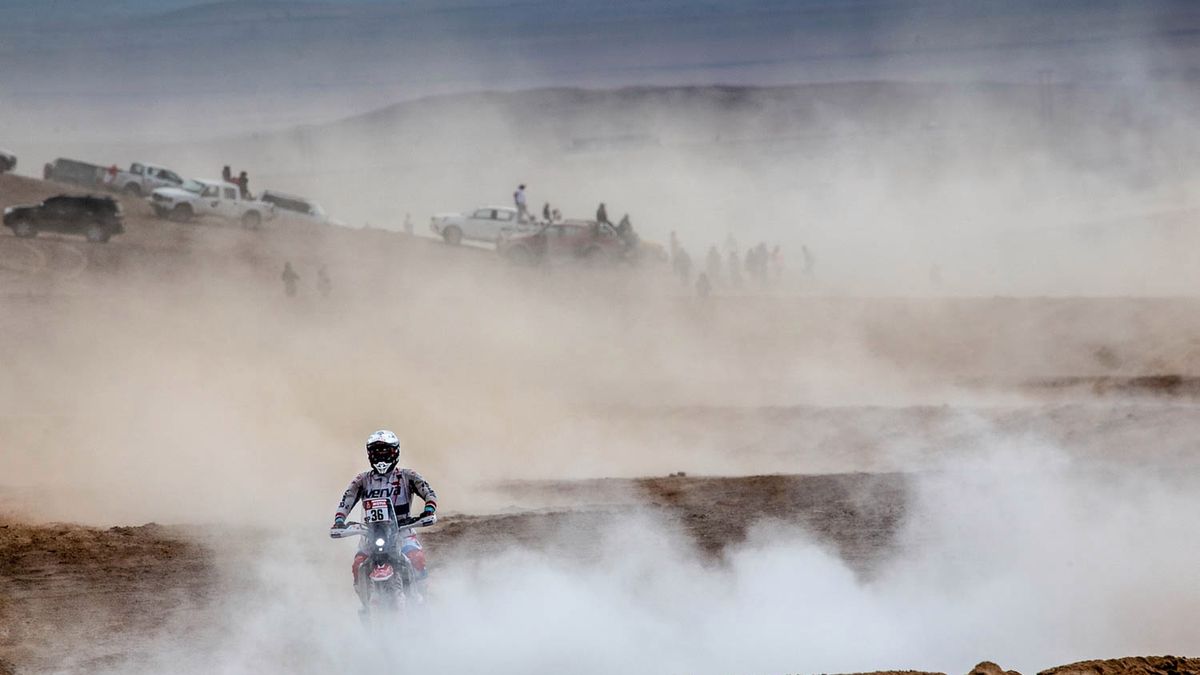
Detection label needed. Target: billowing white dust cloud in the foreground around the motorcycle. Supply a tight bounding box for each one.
[82,429,1200,673]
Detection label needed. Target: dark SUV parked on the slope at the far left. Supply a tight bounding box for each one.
[4,195,125,241]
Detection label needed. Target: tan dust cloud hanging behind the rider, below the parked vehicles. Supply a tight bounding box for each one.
[0,242,907,524]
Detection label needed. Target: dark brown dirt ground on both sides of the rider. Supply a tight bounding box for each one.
[0,474,904,671]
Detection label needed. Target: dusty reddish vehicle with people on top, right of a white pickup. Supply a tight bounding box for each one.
[496,220,636,264]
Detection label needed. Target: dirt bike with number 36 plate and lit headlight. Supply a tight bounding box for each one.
[329,509,438,620]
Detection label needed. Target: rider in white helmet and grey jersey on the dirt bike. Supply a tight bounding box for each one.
[331,429,438,604]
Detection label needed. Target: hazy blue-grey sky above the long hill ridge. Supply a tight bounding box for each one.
[0,0,1200,139]
